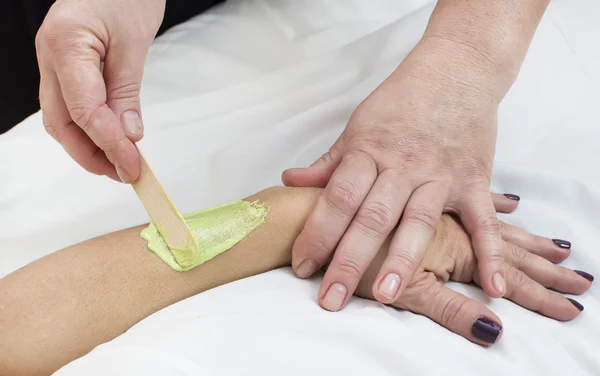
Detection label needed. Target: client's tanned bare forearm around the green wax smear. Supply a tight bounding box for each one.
[0,188,320,375]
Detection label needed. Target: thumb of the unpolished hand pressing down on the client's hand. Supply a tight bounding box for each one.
[281,135,343,188]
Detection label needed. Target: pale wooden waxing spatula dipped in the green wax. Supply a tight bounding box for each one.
[132,153,198,267]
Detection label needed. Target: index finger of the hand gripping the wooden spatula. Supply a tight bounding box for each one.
[56,53,140,183]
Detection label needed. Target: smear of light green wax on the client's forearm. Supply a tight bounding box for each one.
[140,200,268,272]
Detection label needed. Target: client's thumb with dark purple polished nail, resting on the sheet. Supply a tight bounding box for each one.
[394,273,502,346]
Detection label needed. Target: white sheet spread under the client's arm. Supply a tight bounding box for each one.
[0,0,600,376]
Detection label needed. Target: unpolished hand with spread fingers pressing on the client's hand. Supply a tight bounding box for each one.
[283,39,510,310]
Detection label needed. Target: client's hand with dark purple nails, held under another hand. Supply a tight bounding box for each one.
[356,215,593,345]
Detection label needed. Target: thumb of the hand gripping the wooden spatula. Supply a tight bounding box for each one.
[104,42,150,142]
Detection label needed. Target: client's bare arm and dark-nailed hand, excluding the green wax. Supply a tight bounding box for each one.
[0,188,591,375]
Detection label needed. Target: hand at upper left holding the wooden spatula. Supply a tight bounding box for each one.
[36,0,165,183]
